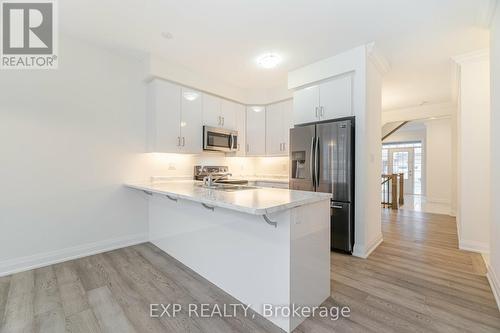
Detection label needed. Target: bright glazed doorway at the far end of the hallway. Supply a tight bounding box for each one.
[382,142,422,195]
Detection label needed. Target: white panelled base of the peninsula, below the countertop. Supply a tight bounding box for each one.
[149,195,330,332]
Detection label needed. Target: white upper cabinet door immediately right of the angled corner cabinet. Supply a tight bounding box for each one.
[266,103,285,156]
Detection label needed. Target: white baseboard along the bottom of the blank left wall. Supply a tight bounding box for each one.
[0,233,148,276]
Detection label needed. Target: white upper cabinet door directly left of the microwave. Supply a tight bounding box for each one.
[180,88,203,154]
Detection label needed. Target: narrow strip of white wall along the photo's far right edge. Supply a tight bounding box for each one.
[488,1,500,308]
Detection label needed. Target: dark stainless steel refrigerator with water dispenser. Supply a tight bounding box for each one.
[290,117,354,254]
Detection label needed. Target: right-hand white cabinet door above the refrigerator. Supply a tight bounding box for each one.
[319,75,353,120]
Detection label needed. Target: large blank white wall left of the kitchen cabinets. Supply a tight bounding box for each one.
[0,38,147,275]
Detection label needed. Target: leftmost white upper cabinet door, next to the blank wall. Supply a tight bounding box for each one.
[147,80,181,153]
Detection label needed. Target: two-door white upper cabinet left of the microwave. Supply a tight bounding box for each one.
[147,79,202,154]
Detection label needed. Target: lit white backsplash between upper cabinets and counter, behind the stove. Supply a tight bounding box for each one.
[144,153,288,178]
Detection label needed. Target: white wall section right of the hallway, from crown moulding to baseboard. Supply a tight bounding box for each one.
[455,51,491,253]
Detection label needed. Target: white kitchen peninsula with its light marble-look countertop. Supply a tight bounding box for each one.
[127,180,331,332]
